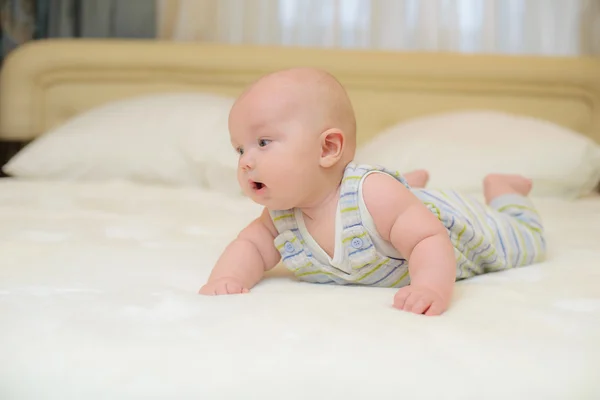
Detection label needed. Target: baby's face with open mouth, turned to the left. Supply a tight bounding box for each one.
[229,87,320,210]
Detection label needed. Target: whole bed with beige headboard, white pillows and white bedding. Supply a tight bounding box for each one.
[0,39,600,400]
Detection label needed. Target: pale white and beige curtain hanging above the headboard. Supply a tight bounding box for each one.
[157,0,600,56]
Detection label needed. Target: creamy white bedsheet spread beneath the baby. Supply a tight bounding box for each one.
[0,179,600,400]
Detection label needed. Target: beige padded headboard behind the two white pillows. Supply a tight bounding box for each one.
[0,39,600,142]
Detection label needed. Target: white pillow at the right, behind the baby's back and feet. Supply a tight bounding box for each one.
[356,110,600,199]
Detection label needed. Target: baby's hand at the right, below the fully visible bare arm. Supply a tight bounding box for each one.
[394,285,448,315]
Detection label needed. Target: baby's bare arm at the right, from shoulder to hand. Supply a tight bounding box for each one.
[363,173,456,315]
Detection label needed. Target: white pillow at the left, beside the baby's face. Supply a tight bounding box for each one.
[3,93,239,192]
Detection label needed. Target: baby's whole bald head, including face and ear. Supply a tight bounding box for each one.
[229,68,356,210]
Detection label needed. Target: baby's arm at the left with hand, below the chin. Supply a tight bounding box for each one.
[199,209,281,295]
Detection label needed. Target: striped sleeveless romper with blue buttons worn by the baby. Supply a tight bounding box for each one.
[270,163,546,287]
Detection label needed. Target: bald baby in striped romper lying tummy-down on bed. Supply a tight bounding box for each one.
[200,68,546,315]
